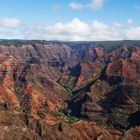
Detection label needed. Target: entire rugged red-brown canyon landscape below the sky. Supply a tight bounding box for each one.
[0,40,140,140]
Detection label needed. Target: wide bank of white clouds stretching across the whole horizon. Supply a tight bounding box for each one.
[0,18,140,41]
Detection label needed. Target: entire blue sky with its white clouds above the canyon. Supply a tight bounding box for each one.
[0,0,140,41]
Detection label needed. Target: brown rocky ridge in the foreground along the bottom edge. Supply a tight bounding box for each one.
[0,111,140,140]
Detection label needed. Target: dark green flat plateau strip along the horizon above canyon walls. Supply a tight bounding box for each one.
[0,39,140,52]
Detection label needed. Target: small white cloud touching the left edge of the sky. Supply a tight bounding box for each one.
[0,18,20,28]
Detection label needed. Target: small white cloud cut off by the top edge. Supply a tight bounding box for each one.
[88,0,105,10]
